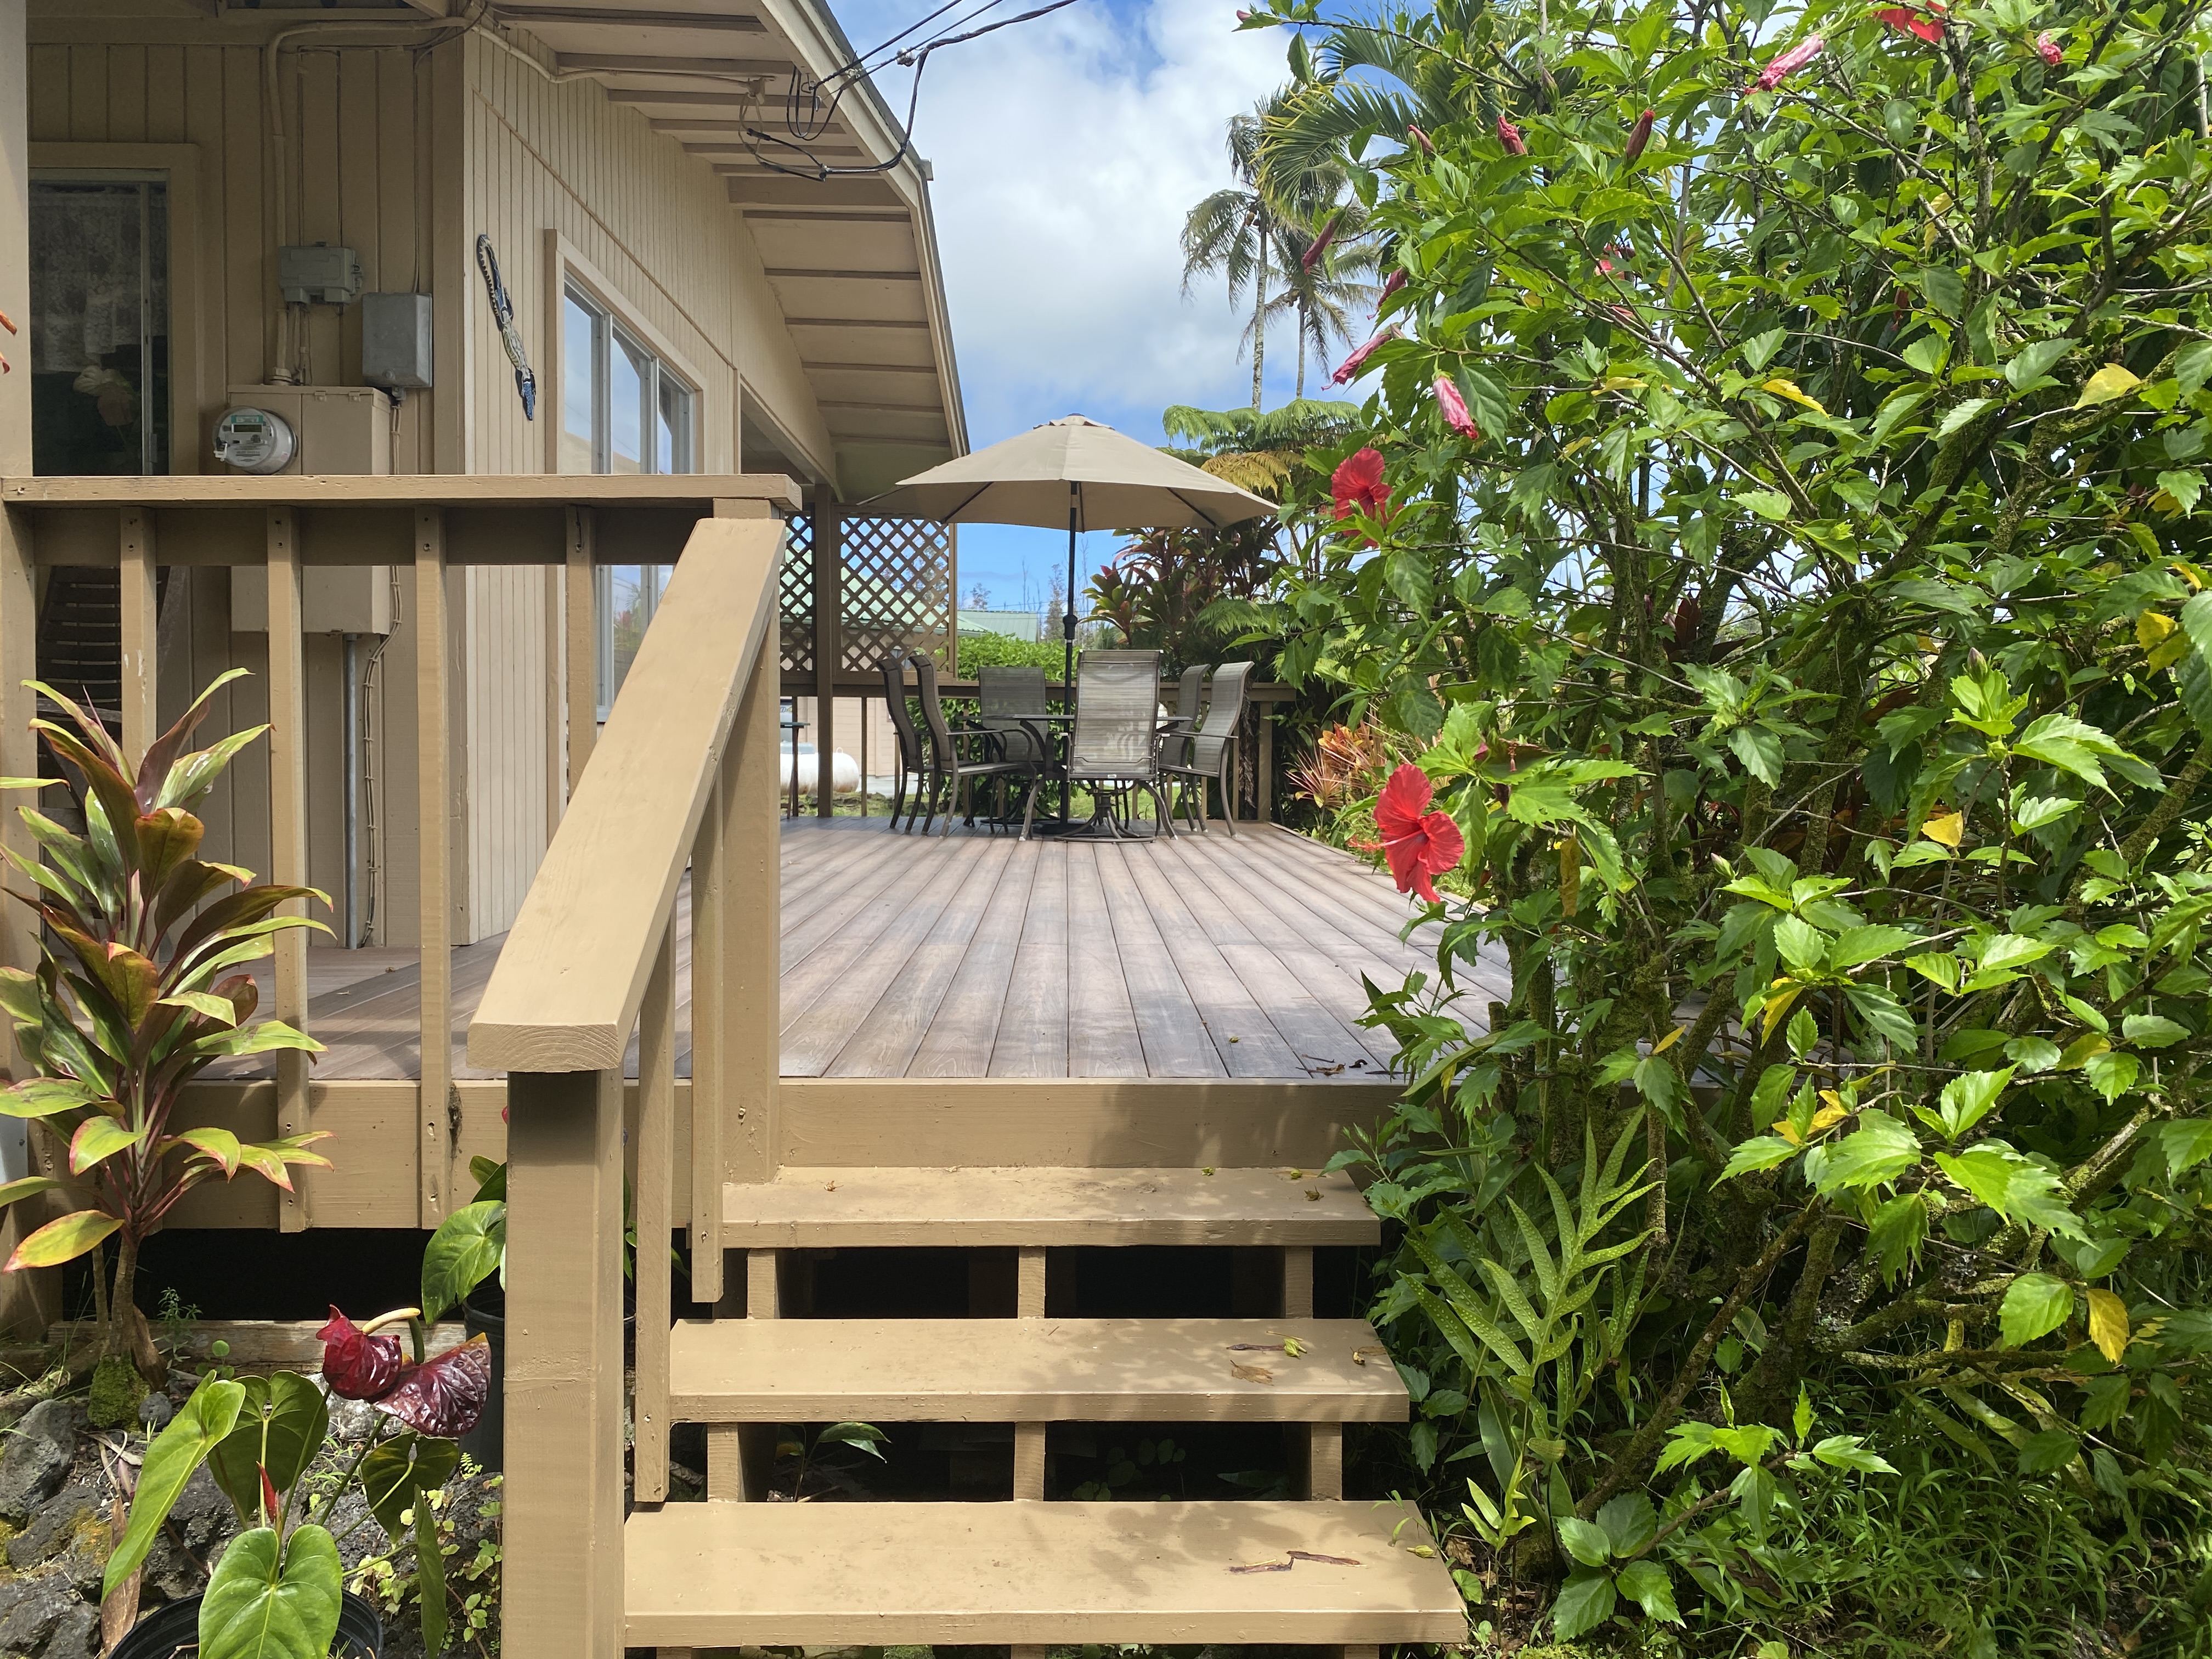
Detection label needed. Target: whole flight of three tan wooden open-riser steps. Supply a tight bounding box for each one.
[624,1168,1466,1659]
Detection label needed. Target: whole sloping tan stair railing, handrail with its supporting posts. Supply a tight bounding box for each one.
[469,506,783,1659]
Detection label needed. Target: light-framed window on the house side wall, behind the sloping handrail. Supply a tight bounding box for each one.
[560,285,697,721]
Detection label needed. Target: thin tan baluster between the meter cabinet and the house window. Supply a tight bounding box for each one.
[414,506,454,1228]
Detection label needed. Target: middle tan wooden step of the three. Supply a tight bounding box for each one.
[668,1318,1407,1423]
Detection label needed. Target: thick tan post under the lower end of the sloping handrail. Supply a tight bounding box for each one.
[500,1066,622,1659]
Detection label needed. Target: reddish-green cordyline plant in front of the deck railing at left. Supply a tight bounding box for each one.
[0,668,330,1383]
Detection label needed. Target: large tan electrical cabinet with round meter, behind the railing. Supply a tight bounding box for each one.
[230,385,392,633]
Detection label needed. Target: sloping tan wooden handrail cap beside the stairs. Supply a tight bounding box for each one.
[469,517,783,1070]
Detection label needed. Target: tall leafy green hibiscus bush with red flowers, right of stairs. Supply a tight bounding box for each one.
[1248,0,2212,1652]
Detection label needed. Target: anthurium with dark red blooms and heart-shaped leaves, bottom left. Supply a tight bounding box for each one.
[101,1307,491,1659]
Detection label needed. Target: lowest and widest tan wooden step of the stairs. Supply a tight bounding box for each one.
[624,1500,1466,1648]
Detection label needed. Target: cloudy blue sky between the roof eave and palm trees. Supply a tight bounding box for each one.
[836,0,1314,608]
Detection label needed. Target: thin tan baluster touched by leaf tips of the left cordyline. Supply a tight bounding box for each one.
[266,506,312,1232]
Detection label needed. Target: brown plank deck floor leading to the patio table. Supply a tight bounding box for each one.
[210,819,1504,1082]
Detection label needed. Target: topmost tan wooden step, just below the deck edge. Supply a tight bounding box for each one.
[721,1168,1383,1250]
